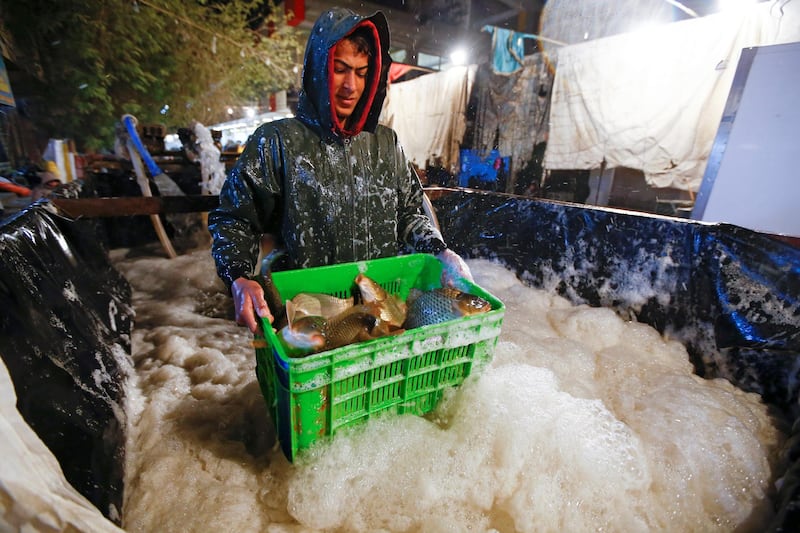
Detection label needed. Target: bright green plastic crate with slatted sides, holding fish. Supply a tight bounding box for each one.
[256,254,505,461]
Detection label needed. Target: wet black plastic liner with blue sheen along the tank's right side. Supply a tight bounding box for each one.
[432,191,800,531]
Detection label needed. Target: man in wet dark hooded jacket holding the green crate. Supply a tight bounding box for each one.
[208,8,472,333]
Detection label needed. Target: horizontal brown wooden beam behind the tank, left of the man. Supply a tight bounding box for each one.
[50,195,219,218]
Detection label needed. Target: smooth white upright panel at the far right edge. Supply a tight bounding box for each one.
[692,43,800,236]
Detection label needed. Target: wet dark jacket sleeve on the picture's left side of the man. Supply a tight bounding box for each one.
[208,129,280,289]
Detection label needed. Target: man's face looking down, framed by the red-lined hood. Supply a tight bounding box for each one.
[331,39,369,122]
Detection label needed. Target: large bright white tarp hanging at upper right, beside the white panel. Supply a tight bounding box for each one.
[544,4,779,191]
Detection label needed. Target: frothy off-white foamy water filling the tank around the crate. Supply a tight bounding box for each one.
[117,250,781,532]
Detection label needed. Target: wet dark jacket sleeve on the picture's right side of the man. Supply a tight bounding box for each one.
[392,131,447,254]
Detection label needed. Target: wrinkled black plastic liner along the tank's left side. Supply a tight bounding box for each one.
[0,202,133,523]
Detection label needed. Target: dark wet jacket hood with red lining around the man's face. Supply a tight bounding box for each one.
[297,8,392,140]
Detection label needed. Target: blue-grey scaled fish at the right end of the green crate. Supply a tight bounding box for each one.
[403,287,492,329]
